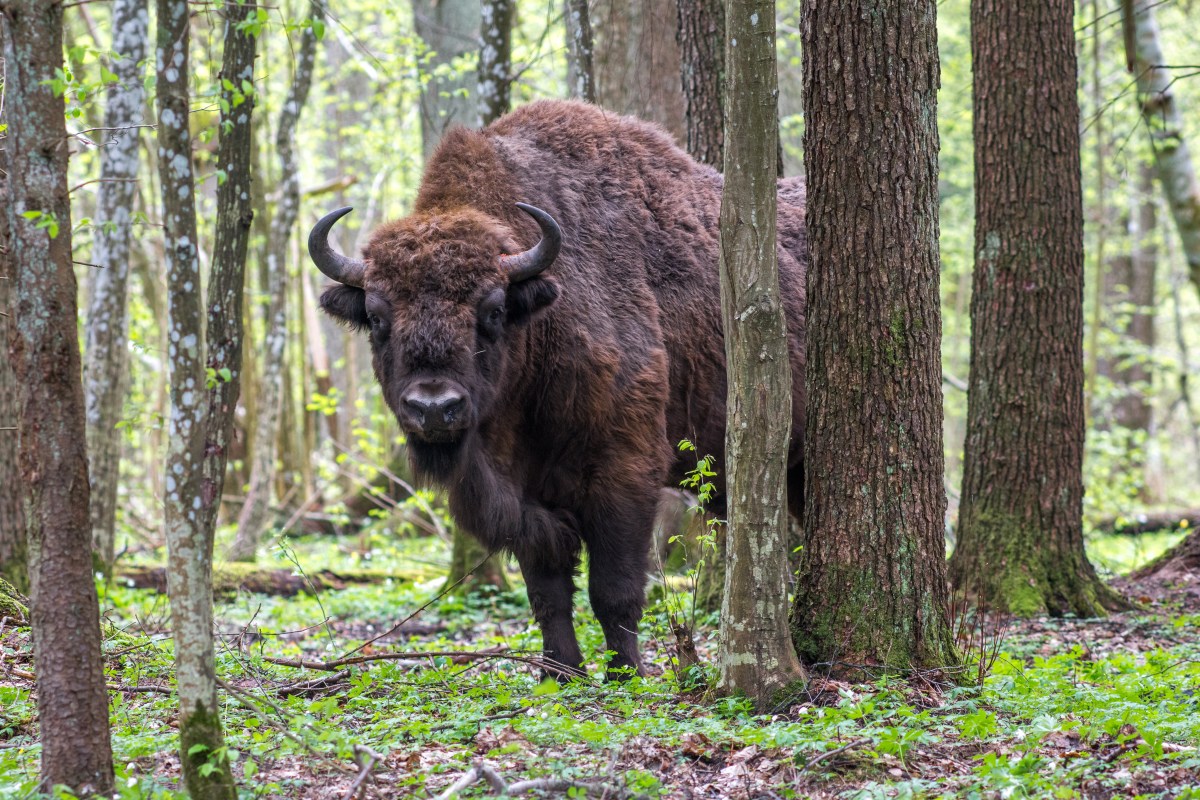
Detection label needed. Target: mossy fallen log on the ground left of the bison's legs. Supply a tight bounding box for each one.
[115,564,407,597]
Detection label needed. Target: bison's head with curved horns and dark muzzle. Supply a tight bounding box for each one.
[308,203,562,479]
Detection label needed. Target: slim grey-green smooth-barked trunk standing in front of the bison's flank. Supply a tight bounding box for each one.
[718,0,805,710]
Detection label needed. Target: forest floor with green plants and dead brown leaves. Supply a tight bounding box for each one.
[0,532,1200,800]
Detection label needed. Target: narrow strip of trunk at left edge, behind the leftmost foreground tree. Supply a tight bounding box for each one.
[0,140,29,594]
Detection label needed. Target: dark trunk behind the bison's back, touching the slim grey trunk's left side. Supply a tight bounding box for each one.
[676,0,725,169]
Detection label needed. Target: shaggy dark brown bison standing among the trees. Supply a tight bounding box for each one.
[310,101,806,676]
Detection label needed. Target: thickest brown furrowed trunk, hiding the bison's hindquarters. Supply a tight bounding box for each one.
[793,0,956,672]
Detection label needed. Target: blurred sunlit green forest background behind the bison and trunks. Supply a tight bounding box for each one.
[11,0,1200,575]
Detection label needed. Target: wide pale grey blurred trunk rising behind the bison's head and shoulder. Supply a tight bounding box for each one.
[413,0,481,161]
